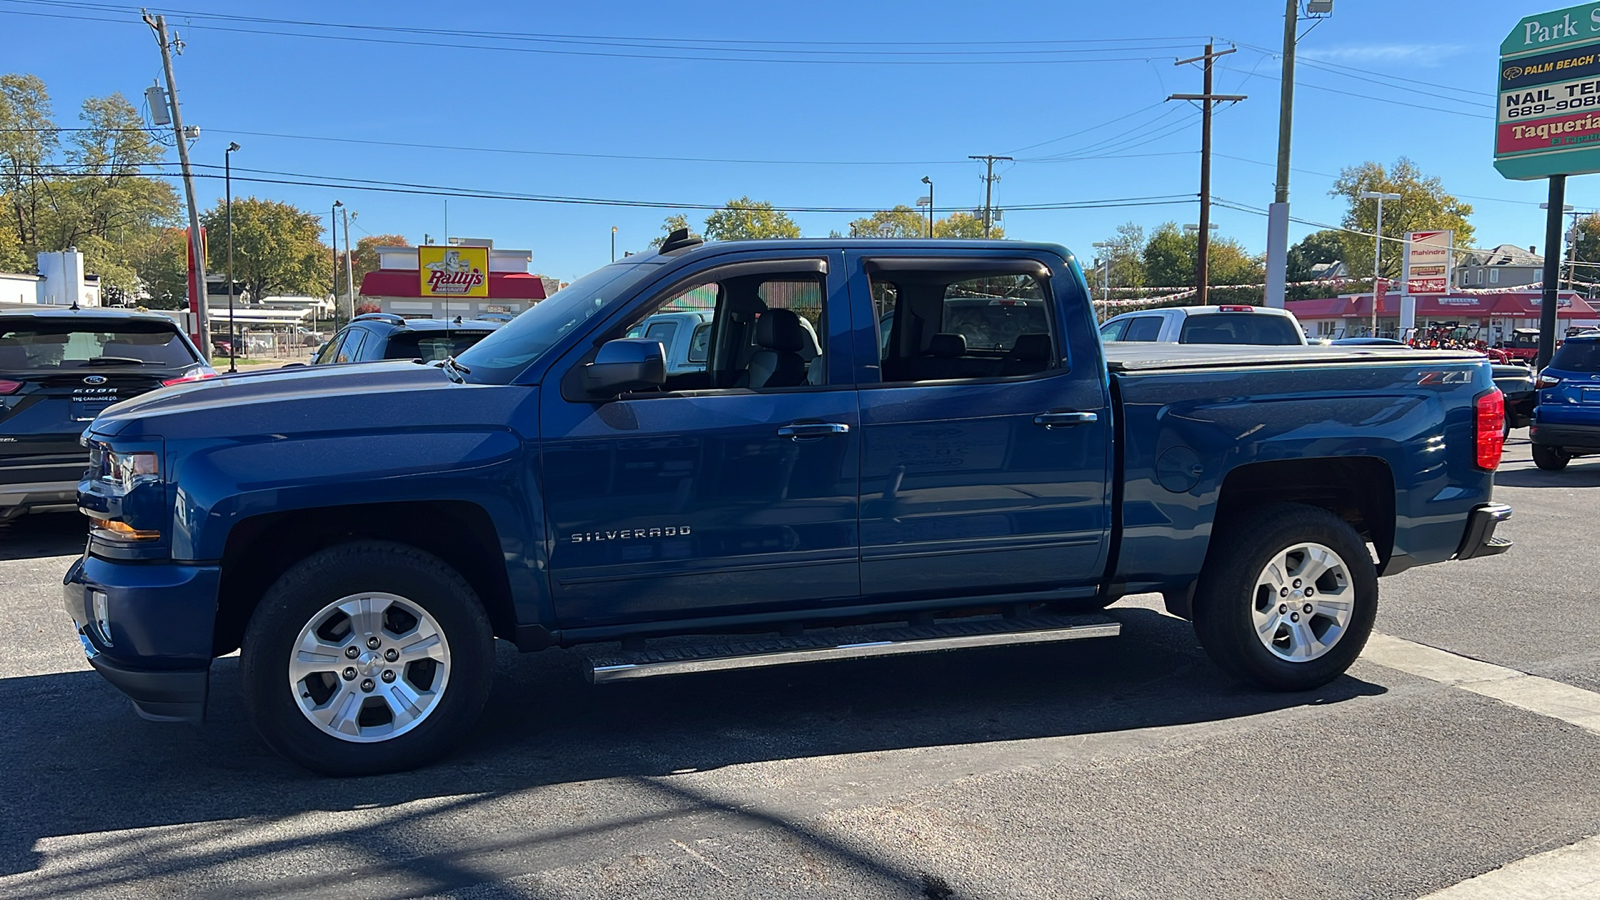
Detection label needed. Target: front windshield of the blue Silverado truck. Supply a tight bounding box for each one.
[459,263,656,384]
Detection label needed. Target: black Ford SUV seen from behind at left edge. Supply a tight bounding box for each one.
[0,309,216,520]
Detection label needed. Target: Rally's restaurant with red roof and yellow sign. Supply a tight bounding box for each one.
[358,237,546,319]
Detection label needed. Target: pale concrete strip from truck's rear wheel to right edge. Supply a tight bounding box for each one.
[1362,633,1600,735]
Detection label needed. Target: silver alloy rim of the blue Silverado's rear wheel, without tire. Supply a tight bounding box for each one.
[1251,543,1355,663]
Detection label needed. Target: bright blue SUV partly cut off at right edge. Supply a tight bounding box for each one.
[1528,335,1600,472]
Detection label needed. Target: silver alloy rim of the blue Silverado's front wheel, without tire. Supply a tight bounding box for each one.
[290,593,450,743]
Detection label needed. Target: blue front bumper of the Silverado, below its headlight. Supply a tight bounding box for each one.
[62,556,219,722]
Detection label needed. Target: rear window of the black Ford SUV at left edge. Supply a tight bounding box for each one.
[0,315,200,370]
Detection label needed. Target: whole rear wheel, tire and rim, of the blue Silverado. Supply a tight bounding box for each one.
[1194,503,1378,690]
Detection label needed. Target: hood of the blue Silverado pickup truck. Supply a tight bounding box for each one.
[90,360,536,439]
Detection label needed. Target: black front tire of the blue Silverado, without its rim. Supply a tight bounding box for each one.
[240,541,494,775]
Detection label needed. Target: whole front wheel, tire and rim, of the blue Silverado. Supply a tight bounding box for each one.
[240,541,494,775]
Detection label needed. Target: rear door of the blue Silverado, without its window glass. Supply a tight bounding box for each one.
[851,248,1112,597]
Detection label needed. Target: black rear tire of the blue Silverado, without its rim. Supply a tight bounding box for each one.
[1194,503,1378,690]
